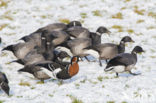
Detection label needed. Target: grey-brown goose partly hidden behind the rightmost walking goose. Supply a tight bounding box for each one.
[89,36,134,66]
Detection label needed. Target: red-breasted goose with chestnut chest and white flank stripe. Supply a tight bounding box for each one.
[37,56,79,80]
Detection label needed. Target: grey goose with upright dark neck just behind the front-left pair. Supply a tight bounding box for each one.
[12,35,54,65]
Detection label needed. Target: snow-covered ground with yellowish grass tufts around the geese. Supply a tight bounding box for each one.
[0,0,156,103]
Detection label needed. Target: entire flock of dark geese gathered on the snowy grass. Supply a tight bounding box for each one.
[0,21,144,95]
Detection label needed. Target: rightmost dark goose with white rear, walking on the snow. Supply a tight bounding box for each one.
[104,46,144,76]
